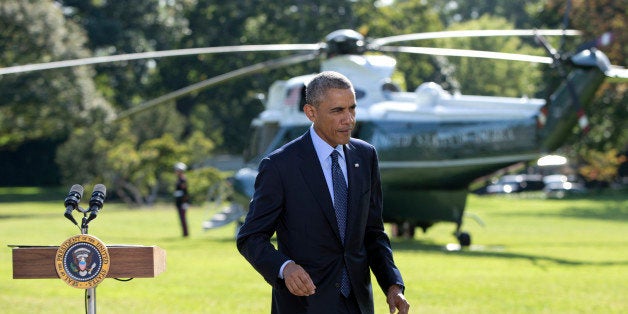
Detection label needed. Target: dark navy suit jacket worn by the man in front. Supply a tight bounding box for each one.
[237,131,403,314]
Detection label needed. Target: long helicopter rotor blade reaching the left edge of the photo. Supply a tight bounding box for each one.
[0,44,322,75]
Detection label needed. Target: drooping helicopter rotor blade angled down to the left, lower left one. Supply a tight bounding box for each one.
[113,51,319,121]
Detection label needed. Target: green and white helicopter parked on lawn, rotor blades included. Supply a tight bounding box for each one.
[0,29,628,246]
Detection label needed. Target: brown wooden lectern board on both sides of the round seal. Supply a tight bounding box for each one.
[11,245,166,279]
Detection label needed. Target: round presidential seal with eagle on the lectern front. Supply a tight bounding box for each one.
[55,234,109,289]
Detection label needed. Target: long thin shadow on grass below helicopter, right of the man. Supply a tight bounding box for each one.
[392,240,628,266]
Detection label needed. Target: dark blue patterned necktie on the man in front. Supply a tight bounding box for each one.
[331,150,351,297]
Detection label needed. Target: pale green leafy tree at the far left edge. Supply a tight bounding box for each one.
[0,0,112,151]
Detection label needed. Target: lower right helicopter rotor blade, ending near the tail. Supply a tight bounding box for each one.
[379,46,553,64]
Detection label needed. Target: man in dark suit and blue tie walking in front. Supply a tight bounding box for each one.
[237,71,410,314]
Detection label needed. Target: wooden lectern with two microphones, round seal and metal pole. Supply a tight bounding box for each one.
[9,184,166,314]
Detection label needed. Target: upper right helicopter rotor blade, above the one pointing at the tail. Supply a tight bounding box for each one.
[370,29,582,50]
